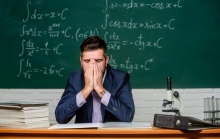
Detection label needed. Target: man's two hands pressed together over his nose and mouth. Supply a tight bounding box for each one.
[82,59,105,99]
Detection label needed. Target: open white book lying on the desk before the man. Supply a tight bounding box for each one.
[48,122,152,129]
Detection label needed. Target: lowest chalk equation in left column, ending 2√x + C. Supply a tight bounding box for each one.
[17,59,65,79]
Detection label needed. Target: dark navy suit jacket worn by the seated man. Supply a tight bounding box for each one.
[55,65,135,123]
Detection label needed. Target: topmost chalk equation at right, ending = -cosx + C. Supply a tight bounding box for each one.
[102,0,184,13]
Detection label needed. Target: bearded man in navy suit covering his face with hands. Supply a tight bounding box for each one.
[55,36,134,124]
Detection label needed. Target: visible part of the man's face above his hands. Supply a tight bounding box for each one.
[80,49,108,74]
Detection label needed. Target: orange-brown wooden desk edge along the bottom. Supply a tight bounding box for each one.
[0,127,220,139]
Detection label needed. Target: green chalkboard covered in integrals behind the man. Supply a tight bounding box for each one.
[0,0,220,88]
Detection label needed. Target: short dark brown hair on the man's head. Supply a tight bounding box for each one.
[80,36,107,56]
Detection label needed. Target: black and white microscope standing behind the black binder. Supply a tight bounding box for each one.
[162,77,184,116]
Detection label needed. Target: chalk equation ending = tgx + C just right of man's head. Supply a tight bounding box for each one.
[108,55,154,73]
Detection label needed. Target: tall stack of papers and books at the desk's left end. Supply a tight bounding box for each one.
[0,102,50,128]
